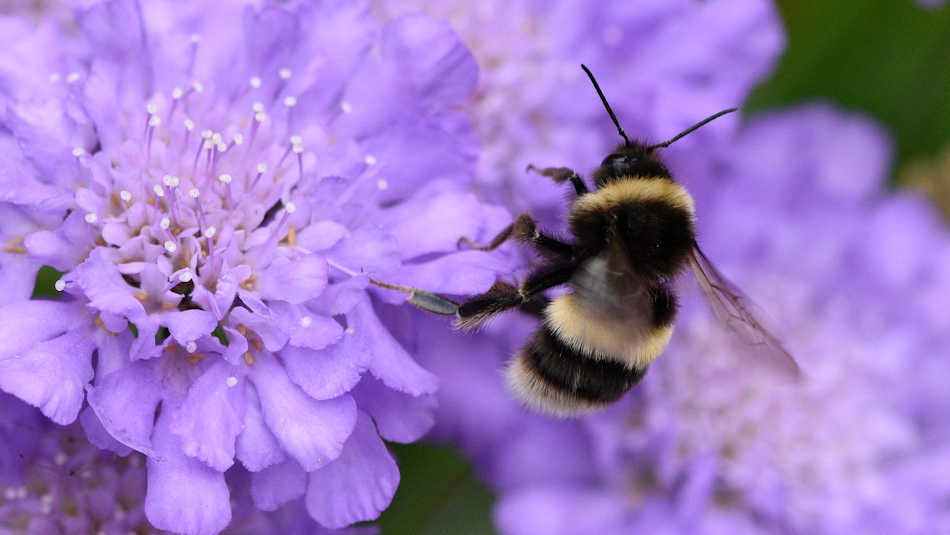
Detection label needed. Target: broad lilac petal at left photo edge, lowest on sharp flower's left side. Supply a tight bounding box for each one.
[0,320,95,425]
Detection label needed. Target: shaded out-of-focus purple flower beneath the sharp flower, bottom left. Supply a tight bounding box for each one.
[0,394,380,535]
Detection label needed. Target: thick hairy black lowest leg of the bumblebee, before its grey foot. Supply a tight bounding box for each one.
[456,262,577,329]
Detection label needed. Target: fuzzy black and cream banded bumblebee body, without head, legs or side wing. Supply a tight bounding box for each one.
[506,172,695,415]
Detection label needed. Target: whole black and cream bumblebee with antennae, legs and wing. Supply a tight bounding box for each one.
[378,65,801,416]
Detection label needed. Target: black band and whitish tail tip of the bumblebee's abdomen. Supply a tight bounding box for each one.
[506,326,646,416]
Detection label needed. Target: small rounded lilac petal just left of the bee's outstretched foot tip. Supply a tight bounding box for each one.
[257,255,327,304]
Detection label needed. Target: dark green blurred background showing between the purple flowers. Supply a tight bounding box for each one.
[379,0,950,535]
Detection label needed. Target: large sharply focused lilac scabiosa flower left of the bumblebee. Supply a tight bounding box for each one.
[0,0,505,533]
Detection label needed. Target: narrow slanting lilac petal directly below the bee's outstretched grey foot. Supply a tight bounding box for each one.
[348,299,439,396]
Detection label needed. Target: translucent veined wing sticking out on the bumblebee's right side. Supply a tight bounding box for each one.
[689,246,802,379]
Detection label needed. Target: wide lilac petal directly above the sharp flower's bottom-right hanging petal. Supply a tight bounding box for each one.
[249,353,356,472]
